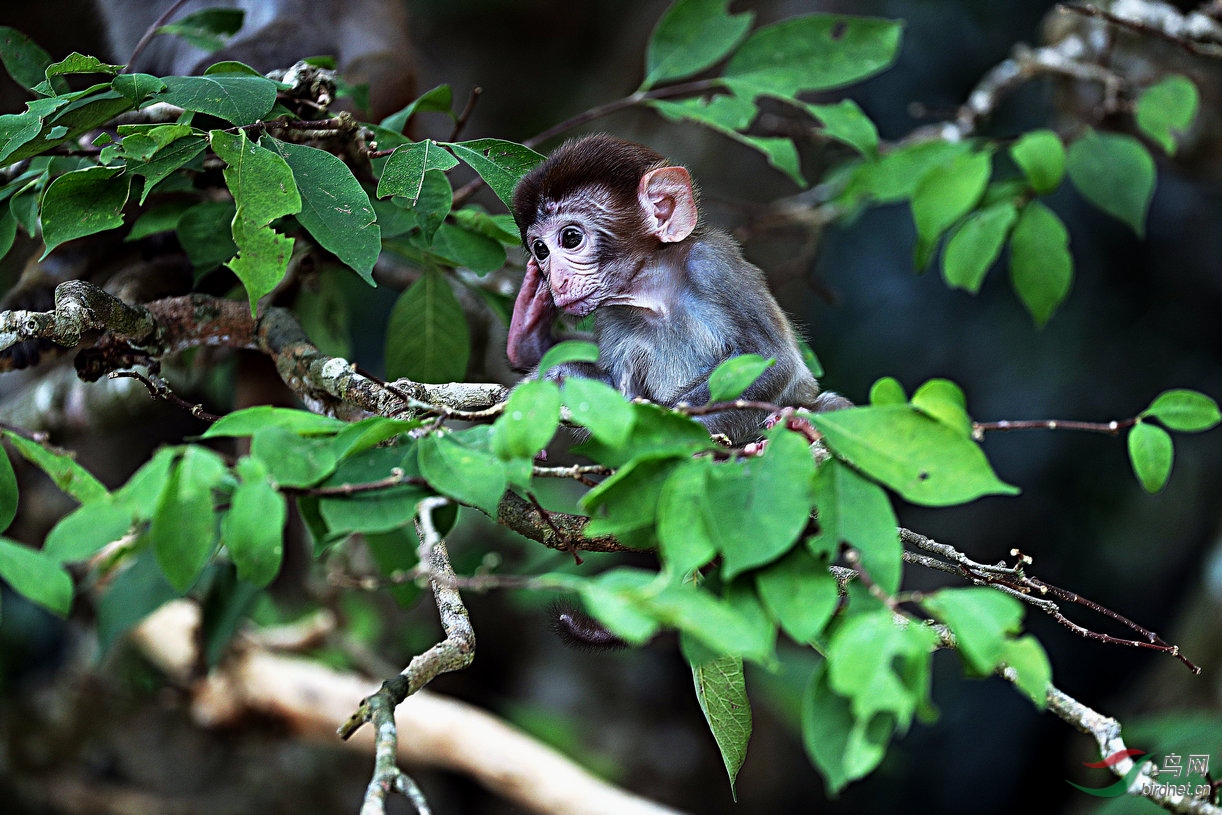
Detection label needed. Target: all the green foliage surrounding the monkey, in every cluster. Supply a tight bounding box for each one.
[0,0,1220,791]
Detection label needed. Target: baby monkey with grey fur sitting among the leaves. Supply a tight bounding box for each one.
[507,134,851,444]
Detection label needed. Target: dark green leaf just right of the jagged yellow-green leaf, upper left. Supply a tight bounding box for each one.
[268,139,381,286]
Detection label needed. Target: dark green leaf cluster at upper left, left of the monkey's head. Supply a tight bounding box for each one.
[0,21,541,381]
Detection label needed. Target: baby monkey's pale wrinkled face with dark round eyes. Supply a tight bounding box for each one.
[527,213,607,316]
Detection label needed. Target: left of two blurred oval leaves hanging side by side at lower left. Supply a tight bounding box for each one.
[148,447,226,591]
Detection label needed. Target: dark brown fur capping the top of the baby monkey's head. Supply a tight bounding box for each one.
[513,133,671,239]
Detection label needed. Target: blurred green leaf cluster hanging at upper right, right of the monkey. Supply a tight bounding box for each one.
[836,76,1198,326]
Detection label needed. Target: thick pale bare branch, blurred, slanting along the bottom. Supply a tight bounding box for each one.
[132,600,698,815]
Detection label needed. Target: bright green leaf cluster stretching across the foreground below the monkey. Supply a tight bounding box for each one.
[0,345,1048,788]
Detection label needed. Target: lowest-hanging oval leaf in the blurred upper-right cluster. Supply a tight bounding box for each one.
[1009,200,1073,326]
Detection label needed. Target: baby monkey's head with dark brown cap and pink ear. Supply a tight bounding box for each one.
[513,134,699,316]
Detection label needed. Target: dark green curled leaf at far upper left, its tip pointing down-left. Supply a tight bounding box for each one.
[42,167,131,258]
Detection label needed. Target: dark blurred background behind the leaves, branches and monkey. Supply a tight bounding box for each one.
[0,0,1222,813]
